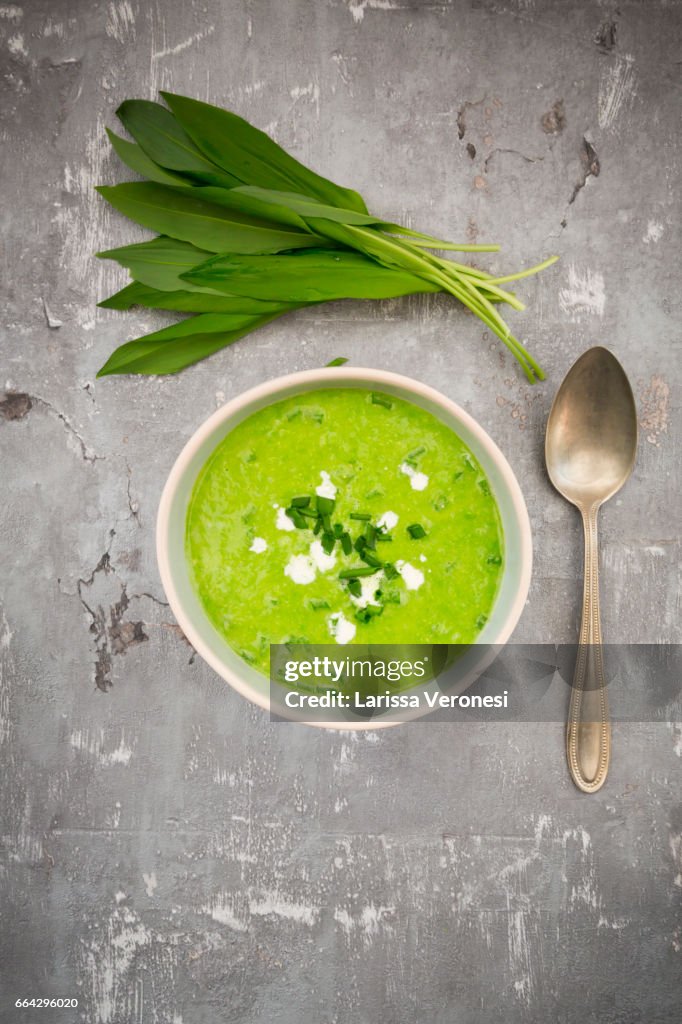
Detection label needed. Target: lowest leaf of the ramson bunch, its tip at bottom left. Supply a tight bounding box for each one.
[97,313,280,377]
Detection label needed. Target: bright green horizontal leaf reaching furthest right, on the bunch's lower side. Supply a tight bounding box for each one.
[181,250,438,302]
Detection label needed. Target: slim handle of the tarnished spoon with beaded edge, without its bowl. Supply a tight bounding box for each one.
[566,503,611,793]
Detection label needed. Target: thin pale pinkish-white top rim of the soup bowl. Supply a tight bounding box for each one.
[156,367,532,730]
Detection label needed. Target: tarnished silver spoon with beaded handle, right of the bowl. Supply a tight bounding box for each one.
[545,346,637,793]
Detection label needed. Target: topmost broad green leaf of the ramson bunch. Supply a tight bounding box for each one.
[161,92,367,213]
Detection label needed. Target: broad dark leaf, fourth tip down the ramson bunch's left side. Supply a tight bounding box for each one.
[97,181,323,253]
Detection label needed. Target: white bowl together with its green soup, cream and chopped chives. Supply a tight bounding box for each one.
[157,367,531,728]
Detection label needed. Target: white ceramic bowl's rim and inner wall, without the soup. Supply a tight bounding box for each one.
[157,367,532,729]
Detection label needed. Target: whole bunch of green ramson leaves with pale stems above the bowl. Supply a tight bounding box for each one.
[97,92,556,381]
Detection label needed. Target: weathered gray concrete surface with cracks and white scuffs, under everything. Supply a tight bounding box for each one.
[0,0,682,1024]
